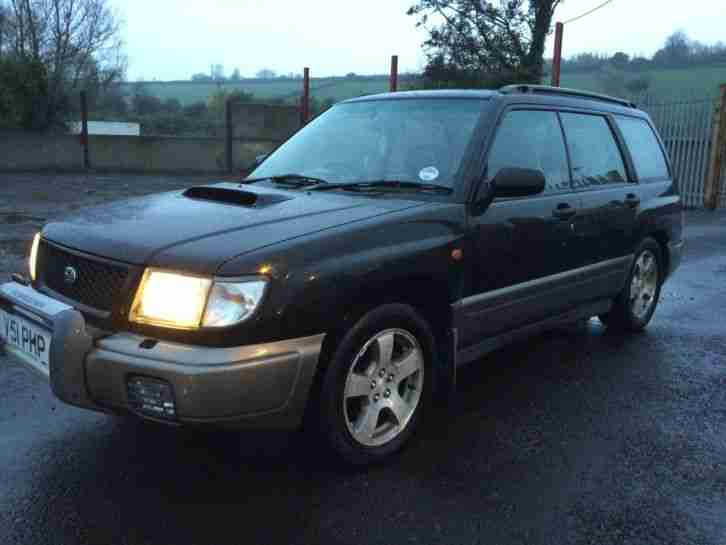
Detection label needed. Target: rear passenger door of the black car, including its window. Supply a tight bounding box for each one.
[560,111,640,302]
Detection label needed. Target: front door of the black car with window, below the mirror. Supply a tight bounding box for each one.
[458,109,579,347]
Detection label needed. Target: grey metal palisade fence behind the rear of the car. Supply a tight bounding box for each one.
[637,97,726,208]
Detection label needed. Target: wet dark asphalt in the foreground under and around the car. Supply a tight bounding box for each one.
[0,212,726,545]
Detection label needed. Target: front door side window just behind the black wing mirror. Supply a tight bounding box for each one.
[487,110,570,193]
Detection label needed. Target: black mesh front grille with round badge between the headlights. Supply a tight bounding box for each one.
[37,241,129,312]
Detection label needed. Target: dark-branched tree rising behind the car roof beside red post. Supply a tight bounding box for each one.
[408,0,561,85]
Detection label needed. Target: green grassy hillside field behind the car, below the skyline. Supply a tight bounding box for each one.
[123,65,726,105]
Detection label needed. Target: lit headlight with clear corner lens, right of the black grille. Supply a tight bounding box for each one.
[129,269,267,329]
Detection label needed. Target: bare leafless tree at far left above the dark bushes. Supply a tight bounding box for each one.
[0,0,126,125]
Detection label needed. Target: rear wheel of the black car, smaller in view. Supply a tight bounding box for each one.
[599,237,664,333]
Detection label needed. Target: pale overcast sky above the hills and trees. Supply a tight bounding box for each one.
[110,0,726,80]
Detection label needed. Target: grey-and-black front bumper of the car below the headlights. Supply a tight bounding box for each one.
[0,284,324,429]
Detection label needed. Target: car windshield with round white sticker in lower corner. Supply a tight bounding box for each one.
[250,99,490,187]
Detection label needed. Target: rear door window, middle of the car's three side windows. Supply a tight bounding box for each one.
[560,113,627,188]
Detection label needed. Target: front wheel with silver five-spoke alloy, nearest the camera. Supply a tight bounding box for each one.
[318,304,436,466]
